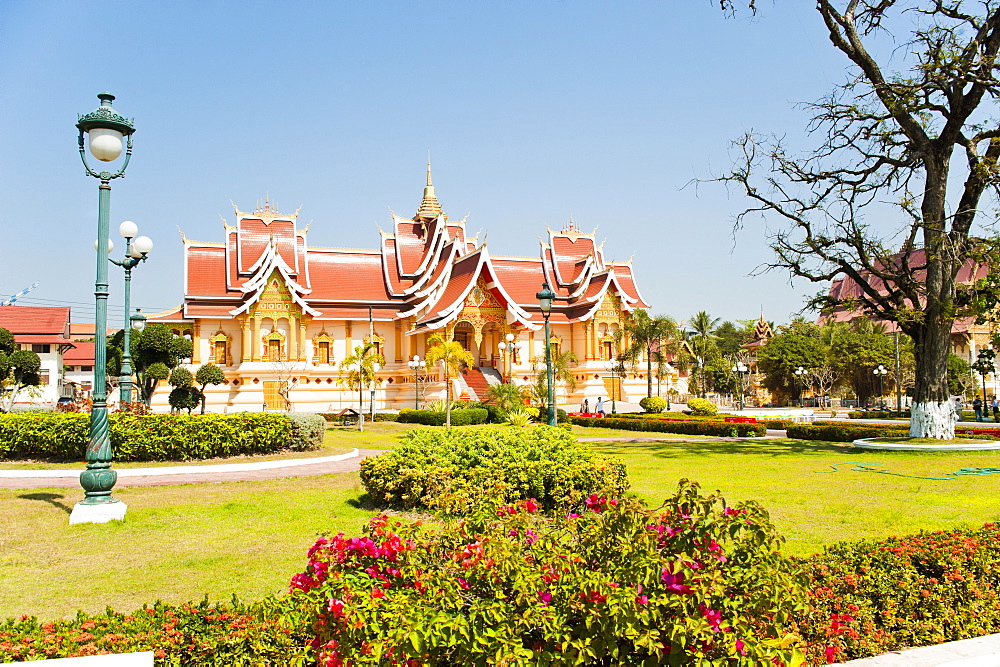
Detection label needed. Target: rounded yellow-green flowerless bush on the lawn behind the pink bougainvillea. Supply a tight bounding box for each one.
[361,426,628,513]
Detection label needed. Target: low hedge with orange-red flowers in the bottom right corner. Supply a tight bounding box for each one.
[799,524,1000,663]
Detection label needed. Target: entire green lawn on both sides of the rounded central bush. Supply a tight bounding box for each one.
[0,423,1000,618]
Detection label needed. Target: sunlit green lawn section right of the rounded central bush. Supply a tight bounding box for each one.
[591,439,1000,555]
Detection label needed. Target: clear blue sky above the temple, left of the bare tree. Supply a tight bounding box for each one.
[0,0,845,328]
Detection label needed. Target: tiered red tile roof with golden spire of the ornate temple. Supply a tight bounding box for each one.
[150,170,648,331]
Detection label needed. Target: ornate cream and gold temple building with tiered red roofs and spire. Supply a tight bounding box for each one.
[149,165,656,412]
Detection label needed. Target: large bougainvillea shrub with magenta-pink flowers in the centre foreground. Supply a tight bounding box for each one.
[290,481,804,667]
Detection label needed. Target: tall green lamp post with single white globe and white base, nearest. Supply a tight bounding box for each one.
[69,93,135,524]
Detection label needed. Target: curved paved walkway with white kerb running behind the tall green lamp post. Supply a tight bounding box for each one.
[0,449,382,489]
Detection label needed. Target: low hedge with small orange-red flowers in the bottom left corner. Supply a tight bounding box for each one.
[0,599,310,666]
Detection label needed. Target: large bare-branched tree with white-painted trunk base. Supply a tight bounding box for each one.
[720,0,1000,438]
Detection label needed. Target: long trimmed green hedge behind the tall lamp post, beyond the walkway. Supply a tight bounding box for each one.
[0,412,308,461]
